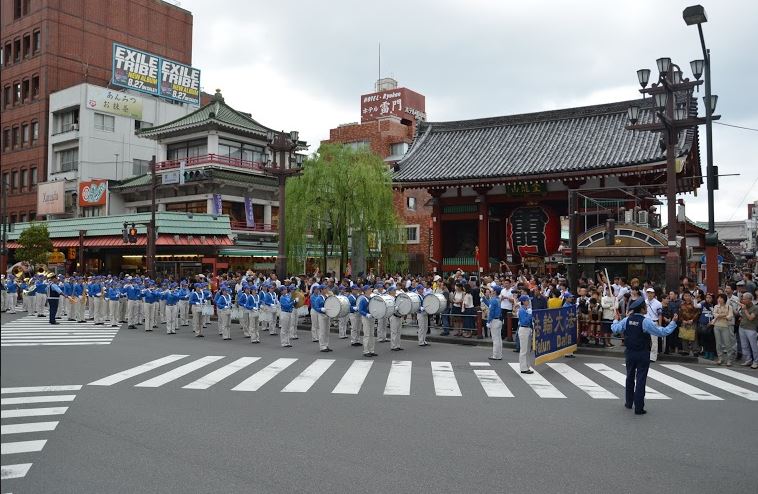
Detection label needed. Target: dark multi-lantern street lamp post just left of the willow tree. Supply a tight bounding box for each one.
[264,130,302,280]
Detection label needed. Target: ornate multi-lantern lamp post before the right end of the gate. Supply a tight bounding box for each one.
[626,57,719,291]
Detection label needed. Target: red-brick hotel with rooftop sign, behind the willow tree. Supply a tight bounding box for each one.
[324,79,433,273]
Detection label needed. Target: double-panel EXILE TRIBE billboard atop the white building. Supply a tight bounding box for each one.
[111,43,200,105]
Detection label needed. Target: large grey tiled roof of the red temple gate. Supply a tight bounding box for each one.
[393,98,697,185]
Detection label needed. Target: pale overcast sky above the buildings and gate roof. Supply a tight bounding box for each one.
[181,0,758,221]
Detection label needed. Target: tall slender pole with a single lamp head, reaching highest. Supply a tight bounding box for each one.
[682,5,719,293]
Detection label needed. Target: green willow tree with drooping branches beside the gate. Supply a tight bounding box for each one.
[285,144,407,273]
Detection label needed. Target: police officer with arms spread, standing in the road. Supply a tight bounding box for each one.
[611,297,678,415]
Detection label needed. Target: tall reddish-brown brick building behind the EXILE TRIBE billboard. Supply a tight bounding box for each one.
[0,0,192,270]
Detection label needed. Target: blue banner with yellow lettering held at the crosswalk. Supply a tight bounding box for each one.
[532,306,577,365]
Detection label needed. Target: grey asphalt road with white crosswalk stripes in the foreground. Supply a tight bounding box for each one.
[0,314,758,494]
